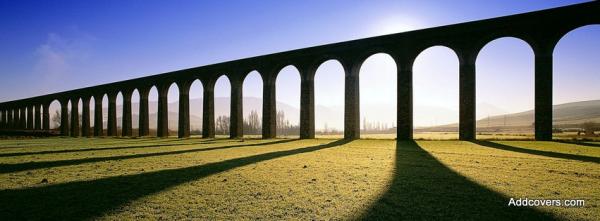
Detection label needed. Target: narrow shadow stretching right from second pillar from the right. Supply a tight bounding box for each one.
[472,140,600,163]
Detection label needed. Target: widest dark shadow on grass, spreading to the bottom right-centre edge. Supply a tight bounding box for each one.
[357,141,556,220]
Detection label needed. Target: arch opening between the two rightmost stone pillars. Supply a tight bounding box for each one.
[475,36,535,138]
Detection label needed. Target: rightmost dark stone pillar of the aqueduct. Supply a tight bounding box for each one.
[535,50,552,140]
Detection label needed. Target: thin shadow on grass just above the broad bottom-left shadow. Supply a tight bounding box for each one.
[0,139,295,174]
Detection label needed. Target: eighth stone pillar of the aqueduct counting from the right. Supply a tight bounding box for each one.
[202,82,215,138]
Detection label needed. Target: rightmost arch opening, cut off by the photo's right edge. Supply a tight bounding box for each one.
[552,24,600,137]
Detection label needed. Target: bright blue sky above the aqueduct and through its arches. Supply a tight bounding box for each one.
[0,0,600,128]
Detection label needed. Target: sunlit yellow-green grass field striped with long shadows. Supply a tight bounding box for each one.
[0,138,600,220]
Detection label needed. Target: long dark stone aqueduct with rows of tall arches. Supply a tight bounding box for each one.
[0,1,600,140]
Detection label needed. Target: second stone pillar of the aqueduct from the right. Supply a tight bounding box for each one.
[458,54,476,140]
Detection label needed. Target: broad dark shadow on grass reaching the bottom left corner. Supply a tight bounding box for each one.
[0,141,346,220]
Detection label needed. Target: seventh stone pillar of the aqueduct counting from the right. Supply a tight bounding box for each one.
[229,78,244,138]
